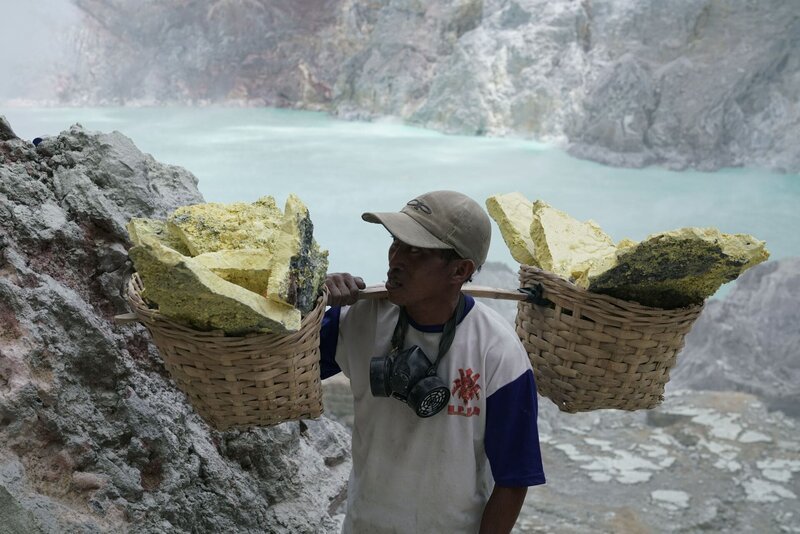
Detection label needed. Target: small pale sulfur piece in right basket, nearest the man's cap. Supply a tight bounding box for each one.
[486,193,540,267]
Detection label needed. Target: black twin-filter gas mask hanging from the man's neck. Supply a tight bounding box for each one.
[369,294,466,417]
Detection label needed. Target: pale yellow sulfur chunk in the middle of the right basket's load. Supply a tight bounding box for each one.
[530,200,617,288]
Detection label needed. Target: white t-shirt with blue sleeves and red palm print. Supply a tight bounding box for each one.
[321,297,545,534]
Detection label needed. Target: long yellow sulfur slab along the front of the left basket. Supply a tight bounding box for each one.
[129,236,301,335]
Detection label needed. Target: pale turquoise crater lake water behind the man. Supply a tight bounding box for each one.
[0,108,800,296]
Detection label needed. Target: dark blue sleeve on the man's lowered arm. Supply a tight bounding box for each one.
[484,370,545,487]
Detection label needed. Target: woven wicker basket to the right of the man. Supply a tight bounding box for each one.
[516,265,703,413]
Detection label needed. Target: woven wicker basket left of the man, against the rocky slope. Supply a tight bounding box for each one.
[127,274,326,430]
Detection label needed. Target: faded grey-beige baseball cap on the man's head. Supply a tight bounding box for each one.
[361,191,492,267]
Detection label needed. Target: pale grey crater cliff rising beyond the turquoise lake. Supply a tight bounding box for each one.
[60,0,800,172]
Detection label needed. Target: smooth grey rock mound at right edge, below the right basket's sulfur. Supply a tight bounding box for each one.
[668,258,800,417]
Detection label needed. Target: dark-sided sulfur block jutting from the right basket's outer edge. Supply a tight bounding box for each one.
[589,228,769,309]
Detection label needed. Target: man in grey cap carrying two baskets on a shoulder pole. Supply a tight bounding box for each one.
[321,191,545,533]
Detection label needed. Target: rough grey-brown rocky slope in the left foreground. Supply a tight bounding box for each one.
[0,119,350,534]
